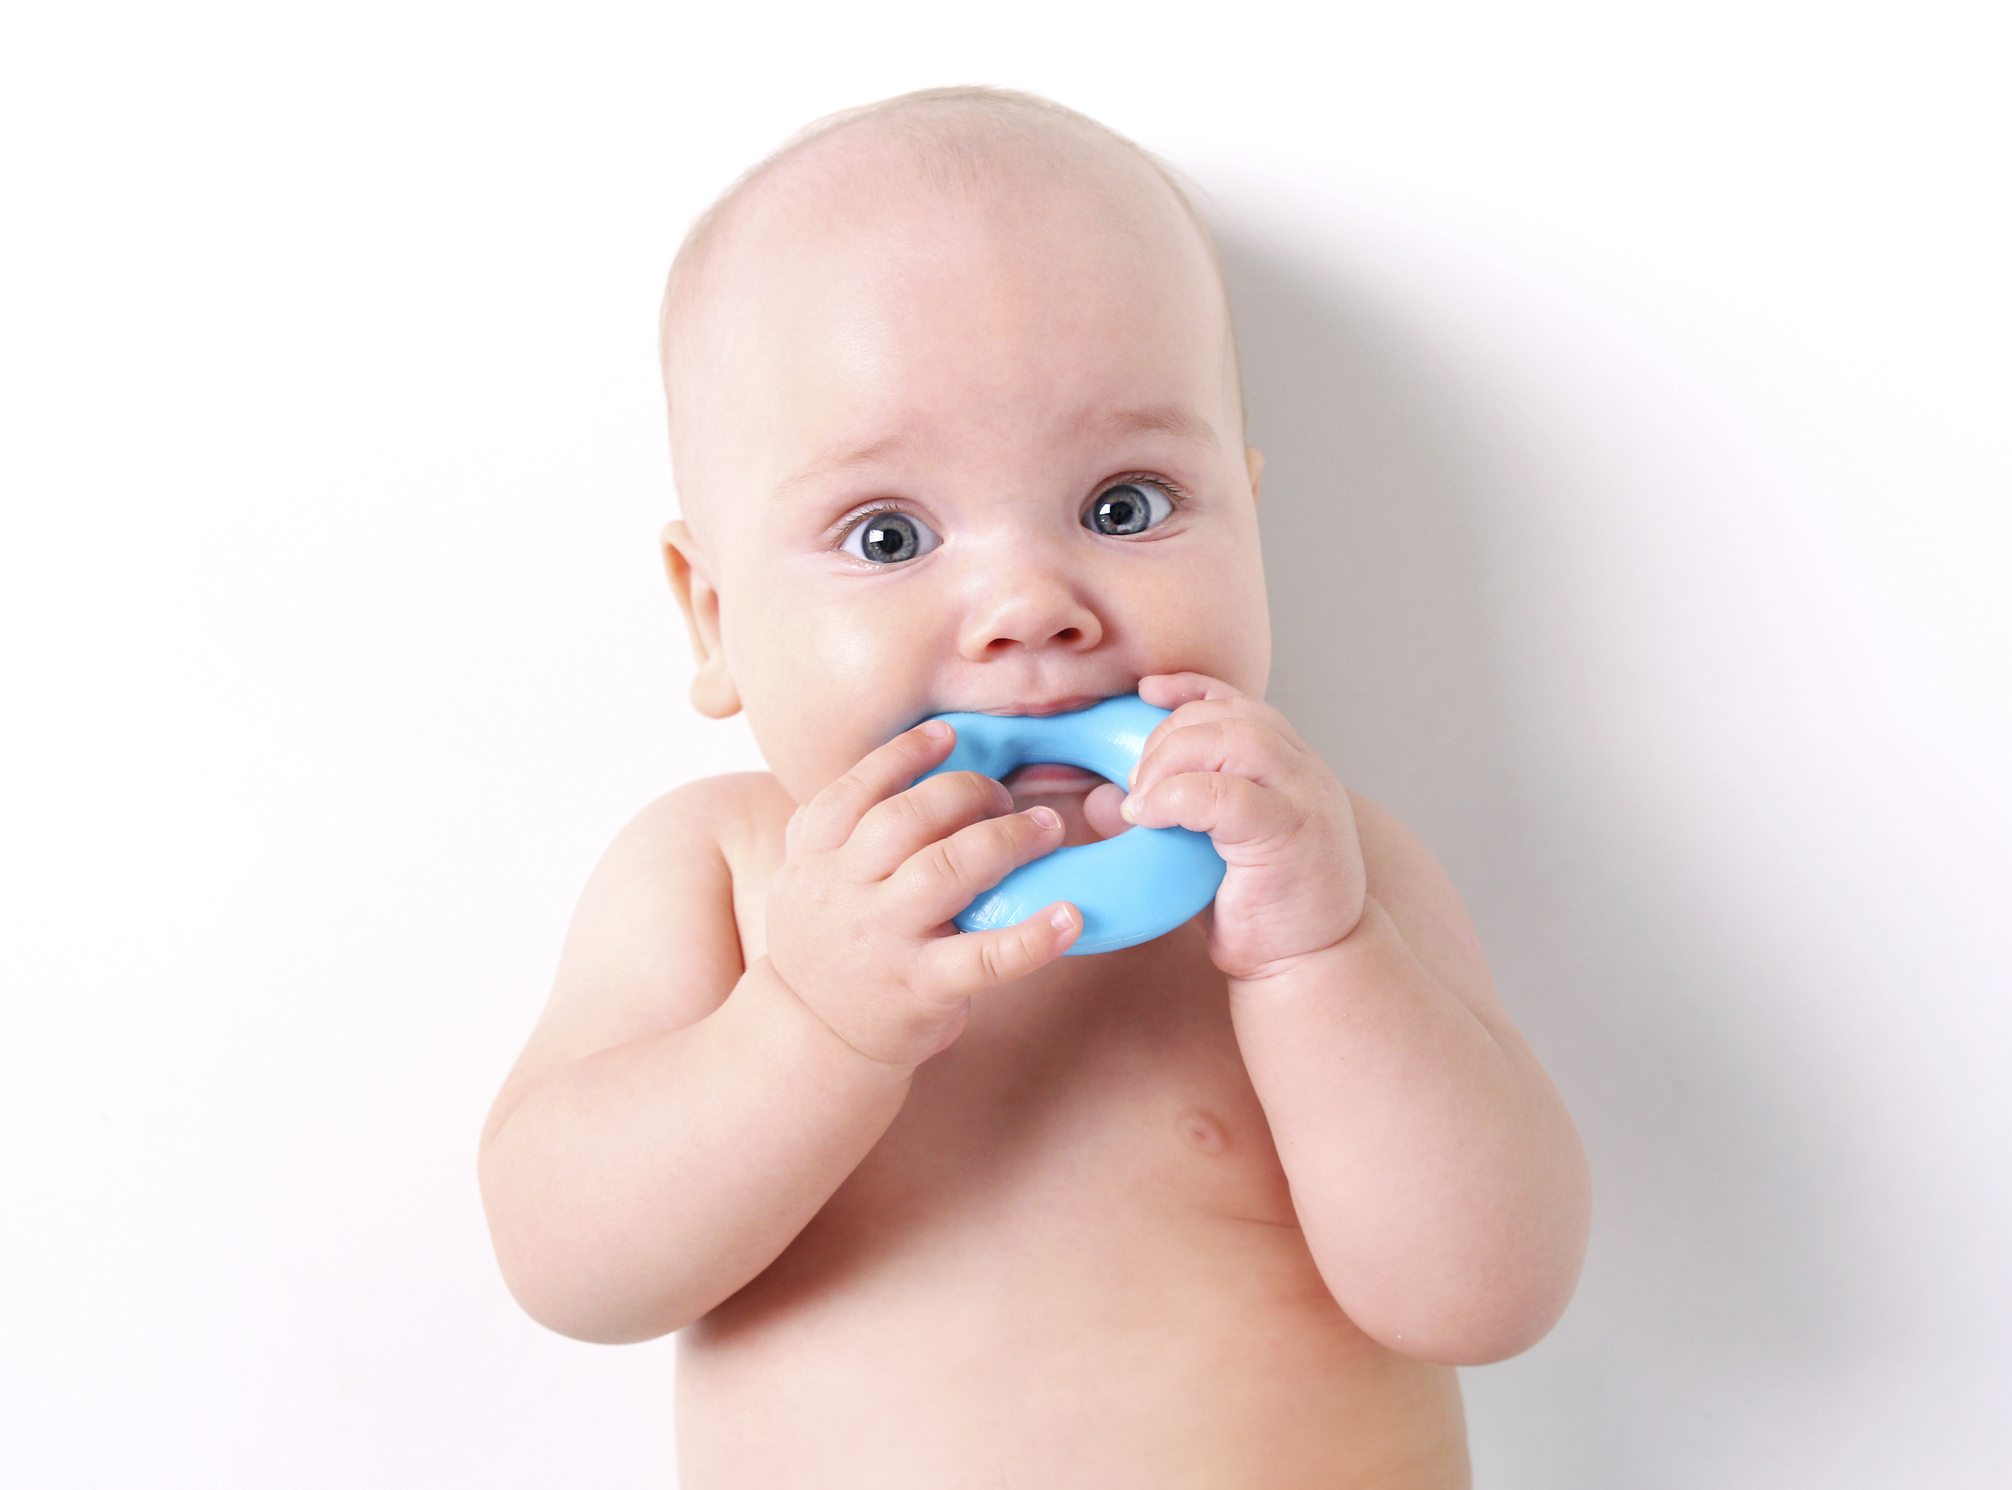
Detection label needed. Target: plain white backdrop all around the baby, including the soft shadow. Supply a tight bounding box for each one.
[0,0,2012,1490]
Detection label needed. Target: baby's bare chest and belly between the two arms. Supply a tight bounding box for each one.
[678,931,1467,1490]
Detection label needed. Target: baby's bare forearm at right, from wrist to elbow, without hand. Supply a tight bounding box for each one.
[1231,901,1589,1363]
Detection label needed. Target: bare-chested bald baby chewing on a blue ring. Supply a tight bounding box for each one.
[483,88,1587,1490]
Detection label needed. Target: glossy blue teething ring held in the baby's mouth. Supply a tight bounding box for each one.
[924,694,1225,957]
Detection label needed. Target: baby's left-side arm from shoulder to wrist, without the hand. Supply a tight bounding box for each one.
[481,776,905,1341]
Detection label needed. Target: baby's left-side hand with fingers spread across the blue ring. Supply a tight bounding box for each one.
[769,720,1082,1066]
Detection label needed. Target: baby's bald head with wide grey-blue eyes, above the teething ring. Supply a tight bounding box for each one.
[664,90,1270,800]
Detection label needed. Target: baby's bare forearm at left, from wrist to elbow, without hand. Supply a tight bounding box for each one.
[481,961,909,1343]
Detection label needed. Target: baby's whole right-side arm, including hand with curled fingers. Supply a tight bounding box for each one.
[1127,674,1589,1365]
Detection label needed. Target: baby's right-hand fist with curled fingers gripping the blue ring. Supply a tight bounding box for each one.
[1123,672,1364,979]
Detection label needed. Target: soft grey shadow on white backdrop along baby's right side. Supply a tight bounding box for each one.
[1221,231,1875,1490]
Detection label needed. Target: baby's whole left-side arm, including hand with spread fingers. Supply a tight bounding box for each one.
[481,730,1080,1341]
